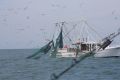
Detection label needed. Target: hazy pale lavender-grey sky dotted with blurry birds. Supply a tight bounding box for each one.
[0,0,120,49]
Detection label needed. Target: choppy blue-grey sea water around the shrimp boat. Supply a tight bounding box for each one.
[0,49,120,80]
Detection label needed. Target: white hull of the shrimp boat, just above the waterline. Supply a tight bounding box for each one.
[56,47,120,58]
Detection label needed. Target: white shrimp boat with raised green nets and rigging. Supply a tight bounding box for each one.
[27,21,120,59]
